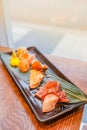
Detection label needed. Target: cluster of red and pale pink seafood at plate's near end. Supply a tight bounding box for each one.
[35,80,69,112]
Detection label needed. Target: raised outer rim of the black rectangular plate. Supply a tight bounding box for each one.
[0,46,86,122]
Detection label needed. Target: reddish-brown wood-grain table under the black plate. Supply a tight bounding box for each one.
[0,47,87,130]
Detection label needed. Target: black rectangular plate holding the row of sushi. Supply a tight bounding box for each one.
[1,47,84,122]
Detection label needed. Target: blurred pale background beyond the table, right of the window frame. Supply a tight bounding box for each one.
[1,0,87,61]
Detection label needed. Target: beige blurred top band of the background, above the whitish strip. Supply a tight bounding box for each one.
[8,0,87,29]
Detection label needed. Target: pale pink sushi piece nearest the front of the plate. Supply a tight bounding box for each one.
[42,94,58,112]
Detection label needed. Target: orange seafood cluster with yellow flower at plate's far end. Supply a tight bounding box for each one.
[10,47,35,72]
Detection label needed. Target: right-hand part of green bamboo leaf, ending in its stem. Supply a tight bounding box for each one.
[47,72,87,103]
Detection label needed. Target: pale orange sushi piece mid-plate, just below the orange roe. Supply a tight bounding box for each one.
[30,69,44,89]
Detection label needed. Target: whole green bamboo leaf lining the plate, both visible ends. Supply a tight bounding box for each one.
[1,53,87,103]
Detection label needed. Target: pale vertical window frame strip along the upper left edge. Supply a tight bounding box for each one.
[0,0,13,47]
